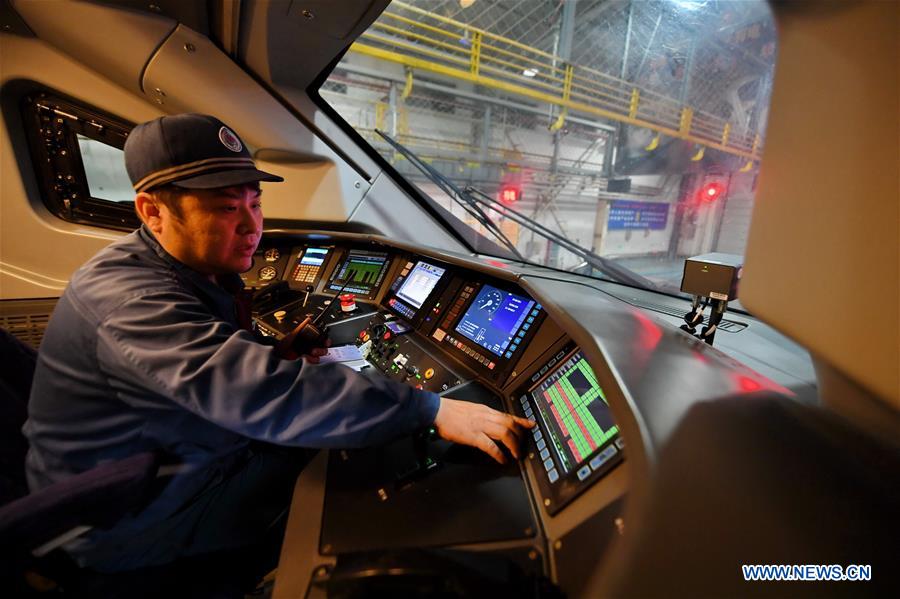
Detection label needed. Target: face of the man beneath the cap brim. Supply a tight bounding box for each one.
[154,185,263,275]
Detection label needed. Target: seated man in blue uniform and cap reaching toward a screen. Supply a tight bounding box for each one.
[24,115,531,571]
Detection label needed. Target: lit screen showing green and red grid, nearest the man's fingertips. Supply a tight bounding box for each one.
[531,351,619,473]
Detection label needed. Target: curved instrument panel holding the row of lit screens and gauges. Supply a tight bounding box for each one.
[244,243,624,516]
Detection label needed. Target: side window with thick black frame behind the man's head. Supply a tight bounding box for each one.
[22,90,140,231]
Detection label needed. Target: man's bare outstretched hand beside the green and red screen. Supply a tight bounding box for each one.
[434,397,534,464]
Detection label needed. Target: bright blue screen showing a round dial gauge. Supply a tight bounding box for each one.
[456,285,534,357]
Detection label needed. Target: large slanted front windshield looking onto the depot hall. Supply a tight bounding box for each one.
[319,0,775,291]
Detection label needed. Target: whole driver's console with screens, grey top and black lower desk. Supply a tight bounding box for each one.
[243,231,814,596]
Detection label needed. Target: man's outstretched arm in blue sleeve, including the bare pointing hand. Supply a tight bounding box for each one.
[97,290,531,462]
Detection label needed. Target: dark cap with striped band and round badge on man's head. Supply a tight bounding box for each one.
[125,114,284,192]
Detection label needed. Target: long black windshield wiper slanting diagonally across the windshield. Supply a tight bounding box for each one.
[375,129,657,290]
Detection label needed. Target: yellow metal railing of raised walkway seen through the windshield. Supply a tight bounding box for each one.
[350,0,761,166]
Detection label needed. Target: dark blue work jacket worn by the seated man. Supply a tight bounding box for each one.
[23,227,439,563]
